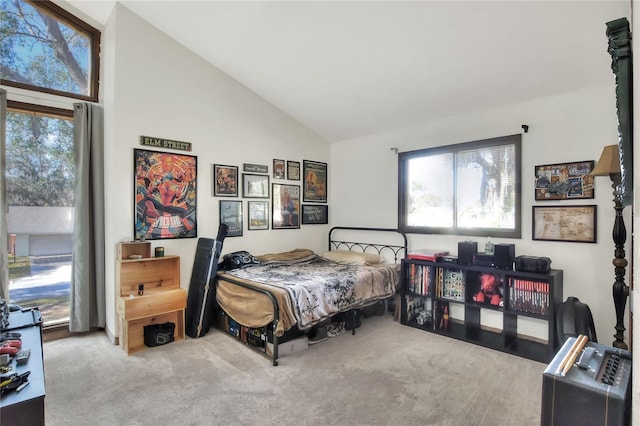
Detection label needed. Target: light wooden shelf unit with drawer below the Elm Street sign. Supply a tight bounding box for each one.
[116,242,187,355]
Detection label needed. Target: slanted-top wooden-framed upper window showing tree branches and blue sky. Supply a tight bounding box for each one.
[0,0,100,101]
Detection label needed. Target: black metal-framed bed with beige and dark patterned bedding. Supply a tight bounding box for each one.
[214,227,407,366]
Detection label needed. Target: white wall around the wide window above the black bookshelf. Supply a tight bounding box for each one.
[329,85,631,345]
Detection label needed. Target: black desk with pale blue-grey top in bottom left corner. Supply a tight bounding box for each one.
[0,310,44,426]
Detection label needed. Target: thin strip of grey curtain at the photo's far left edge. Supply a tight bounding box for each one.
[0,89,9,303]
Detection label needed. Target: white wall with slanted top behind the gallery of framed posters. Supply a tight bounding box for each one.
[103,4,329,336]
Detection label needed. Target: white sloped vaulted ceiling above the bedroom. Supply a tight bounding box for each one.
[63,0,631,142]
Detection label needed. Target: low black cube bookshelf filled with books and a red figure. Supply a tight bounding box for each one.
[401,259,563,363]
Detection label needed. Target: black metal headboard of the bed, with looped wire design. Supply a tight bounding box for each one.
[329,226,407,263]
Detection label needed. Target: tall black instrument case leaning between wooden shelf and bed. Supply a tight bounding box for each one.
[185,224,228,337]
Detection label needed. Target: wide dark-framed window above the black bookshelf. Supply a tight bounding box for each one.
[398,135,521,238]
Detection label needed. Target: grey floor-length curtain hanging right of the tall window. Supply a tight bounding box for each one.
[69,103,106,332]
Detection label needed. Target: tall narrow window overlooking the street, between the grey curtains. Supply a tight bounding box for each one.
[6,102,74,325]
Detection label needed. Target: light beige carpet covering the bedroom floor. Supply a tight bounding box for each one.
[44,315,546,426]
